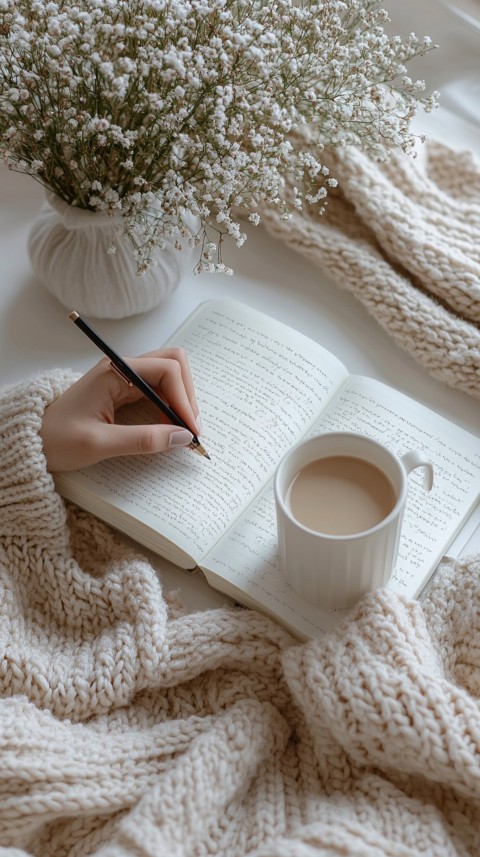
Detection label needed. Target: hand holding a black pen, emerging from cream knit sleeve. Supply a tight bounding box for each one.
[41,348,201,471]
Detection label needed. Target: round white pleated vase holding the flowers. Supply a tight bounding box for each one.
[28,191,195,318]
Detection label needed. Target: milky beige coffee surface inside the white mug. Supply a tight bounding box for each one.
[287,455,397,536]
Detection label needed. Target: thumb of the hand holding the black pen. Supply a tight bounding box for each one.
[92,423,193,460]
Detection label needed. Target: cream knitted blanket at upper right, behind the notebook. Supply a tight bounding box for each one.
[262,141,480,399]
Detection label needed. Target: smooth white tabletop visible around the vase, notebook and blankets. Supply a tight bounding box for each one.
[0,0,480,609]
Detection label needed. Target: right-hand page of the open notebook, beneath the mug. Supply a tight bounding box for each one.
[205,376,480,637]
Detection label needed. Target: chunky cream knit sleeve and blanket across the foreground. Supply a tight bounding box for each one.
[0,373,480,857]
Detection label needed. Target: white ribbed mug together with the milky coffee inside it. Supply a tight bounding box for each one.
[274,432,433,609]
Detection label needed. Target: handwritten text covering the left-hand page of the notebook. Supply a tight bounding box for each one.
[76,307,342,559]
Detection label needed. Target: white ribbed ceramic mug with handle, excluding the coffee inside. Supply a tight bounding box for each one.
[274,432,433,609]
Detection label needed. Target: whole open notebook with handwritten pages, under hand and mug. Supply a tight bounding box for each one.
[56,299,480,638]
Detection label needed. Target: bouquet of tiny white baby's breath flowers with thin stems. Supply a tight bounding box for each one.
[0,0,436,273]
